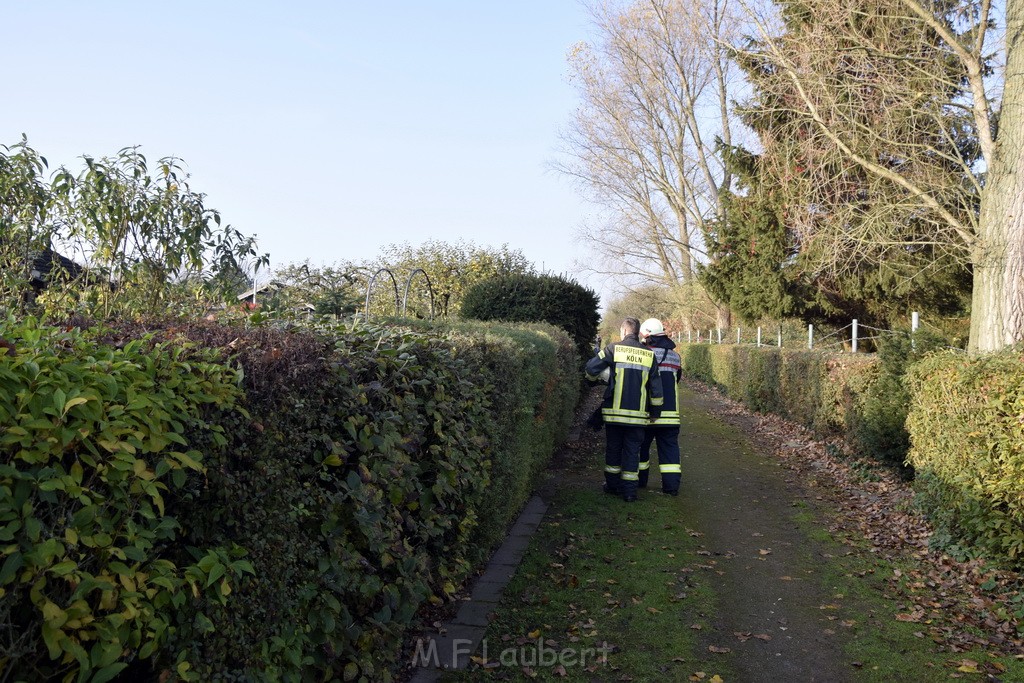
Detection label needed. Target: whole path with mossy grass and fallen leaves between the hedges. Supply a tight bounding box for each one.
[441,384,1024,683]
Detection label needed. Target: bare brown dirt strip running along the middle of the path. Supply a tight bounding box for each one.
[679,391,851,681]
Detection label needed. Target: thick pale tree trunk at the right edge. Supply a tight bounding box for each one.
[969,0,1024,353]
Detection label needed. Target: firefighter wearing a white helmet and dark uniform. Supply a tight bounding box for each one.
[639,317,682,496]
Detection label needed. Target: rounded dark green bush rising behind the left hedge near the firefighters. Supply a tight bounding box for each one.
[462,274,600,368]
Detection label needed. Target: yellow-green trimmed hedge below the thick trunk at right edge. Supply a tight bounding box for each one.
[906,348,1024,568]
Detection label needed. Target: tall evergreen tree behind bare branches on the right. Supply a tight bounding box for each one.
[705,0,981,324]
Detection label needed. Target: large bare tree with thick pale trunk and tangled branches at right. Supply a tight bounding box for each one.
[742,0,1024,352]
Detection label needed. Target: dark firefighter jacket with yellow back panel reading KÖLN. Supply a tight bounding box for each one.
[587,335,664,426]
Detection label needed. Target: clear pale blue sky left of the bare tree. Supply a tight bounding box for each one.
[0,0,593,294]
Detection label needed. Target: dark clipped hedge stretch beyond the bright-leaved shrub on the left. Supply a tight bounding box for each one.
[164,317,577,681]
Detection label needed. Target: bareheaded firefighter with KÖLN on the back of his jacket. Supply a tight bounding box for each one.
[586,317,664,503]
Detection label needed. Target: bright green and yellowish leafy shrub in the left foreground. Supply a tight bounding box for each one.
[0,318,251,683]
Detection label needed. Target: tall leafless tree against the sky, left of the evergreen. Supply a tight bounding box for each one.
[554,0,734,325]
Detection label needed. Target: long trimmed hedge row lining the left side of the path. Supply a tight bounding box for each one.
[0,321,579,681]
